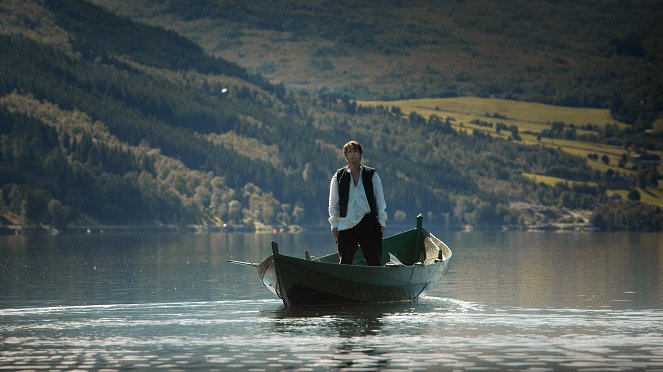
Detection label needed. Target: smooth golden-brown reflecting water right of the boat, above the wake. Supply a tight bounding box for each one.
[434,233,663,308]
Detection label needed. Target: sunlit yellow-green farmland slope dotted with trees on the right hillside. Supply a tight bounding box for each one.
[357,97,663,207]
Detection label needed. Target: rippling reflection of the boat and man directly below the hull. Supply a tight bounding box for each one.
[264,298,464,370]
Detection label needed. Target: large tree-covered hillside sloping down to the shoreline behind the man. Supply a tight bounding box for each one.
[0,1,663,230]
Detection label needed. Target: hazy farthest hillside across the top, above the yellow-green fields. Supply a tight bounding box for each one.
[93,0,663,127]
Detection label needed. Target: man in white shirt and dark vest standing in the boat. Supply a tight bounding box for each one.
[329,141,387,266]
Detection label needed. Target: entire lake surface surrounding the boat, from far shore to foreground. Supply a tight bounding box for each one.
[0,229,663,371]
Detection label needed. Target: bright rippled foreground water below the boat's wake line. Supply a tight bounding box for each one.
[0,297,663,370]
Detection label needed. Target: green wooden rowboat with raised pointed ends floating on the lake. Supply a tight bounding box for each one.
[228,215,451,308]
